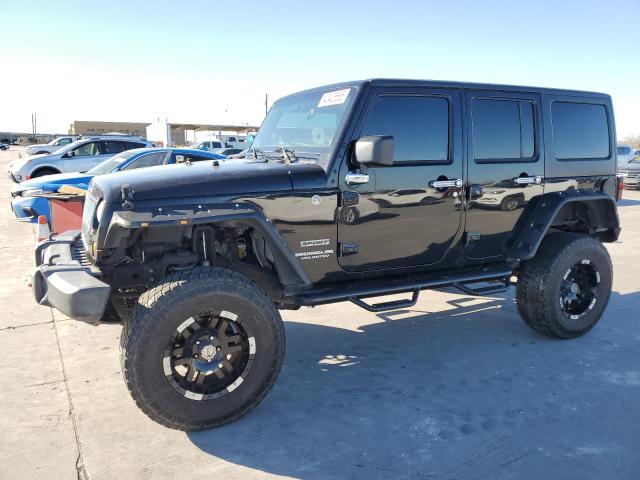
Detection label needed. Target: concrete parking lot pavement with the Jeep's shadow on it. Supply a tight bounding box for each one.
[0,150,640,480]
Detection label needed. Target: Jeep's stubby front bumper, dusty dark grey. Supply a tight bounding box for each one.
[31,230,111,322]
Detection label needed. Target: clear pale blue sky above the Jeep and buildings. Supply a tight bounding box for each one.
[0,0,640,139]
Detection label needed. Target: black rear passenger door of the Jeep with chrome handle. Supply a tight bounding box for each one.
[464,91,544,259]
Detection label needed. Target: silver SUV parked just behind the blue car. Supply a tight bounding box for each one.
[9,137,152,182]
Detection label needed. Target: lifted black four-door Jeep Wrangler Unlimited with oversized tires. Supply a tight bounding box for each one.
[32,80,620,430]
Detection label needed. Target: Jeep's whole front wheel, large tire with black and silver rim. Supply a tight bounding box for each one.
[122,268,285,430]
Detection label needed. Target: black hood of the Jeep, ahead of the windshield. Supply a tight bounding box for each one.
[93,161,324,202]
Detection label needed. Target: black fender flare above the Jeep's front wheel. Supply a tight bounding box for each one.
[104,205,311,287]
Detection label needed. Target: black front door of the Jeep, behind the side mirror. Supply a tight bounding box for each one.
[338,87,463,271]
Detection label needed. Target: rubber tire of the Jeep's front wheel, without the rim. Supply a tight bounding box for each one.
[121,267,285,430]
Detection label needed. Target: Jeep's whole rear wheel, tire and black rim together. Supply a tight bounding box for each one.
[516,233,613,338]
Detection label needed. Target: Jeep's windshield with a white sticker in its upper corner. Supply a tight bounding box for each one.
[251,88,356,165]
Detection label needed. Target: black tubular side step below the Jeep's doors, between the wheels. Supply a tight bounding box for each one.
[285,263,513,311]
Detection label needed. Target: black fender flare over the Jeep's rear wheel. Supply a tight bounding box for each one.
[504,190,620,260]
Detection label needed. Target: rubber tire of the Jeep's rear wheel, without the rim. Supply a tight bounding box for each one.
[516,233,613,339]
